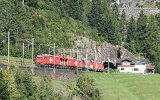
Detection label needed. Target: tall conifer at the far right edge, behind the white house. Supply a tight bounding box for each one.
[143,15,160,62]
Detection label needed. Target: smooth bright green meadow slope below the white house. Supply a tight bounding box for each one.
[89,73,160,100]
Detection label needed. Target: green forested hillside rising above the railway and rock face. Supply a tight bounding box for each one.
[0,0,160,70]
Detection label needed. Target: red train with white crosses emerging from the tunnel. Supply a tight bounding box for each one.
[35,54,104,71]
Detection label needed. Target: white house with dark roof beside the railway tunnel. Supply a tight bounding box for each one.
[117,59,154,74]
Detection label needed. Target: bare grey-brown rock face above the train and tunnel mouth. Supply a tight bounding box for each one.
[75,37,134,62]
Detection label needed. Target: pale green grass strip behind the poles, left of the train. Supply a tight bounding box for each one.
[0,56,32,66]
